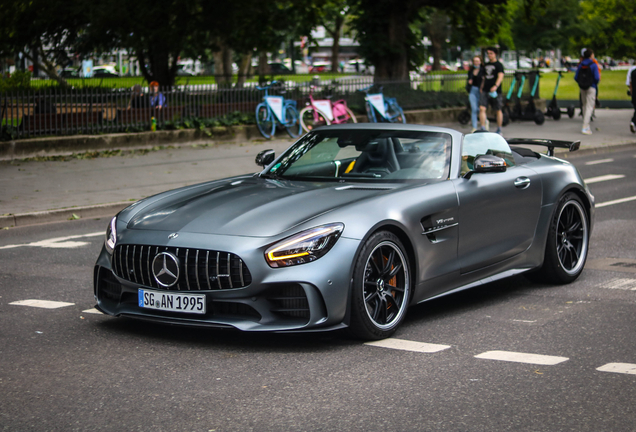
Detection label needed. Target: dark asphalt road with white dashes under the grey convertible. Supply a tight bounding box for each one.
[0,148,636,432]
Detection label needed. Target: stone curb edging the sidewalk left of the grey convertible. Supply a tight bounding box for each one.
[0,201,132,229]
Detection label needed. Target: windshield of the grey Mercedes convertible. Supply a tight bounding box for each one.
[266,130,451,181]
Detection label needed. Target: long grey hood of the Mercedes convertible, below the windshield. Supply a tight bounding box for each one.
[126,177,394,237]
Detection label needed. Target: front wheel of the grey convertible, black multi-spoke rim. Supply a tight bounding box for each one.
[349,231,412,340]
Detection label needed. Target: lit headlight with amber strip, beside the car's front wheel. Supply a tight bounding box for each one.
[265,223,344,268]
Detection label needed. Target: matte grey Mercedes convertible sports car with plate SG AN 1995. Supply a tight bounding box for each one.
[94,124,594,339]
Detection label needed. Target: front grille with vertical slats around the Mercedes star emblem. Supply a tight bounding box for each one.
[112,245,252,291]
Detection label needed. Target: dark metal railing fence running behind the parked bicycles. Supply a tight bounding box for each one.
[0,74,530,140]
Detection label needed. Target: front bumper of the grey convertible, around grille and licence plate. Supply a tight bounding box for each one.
[94,235,359,331]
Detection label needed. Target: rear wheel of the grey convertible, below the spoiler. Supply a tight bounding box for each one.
[530,192,590,284]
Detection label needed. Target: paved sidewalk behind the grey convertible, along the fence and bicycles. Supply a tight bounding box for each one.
[0,109,636,228]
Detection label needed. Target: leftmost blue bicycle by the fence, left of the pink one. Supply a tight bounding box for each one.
[256,81,302,139]
